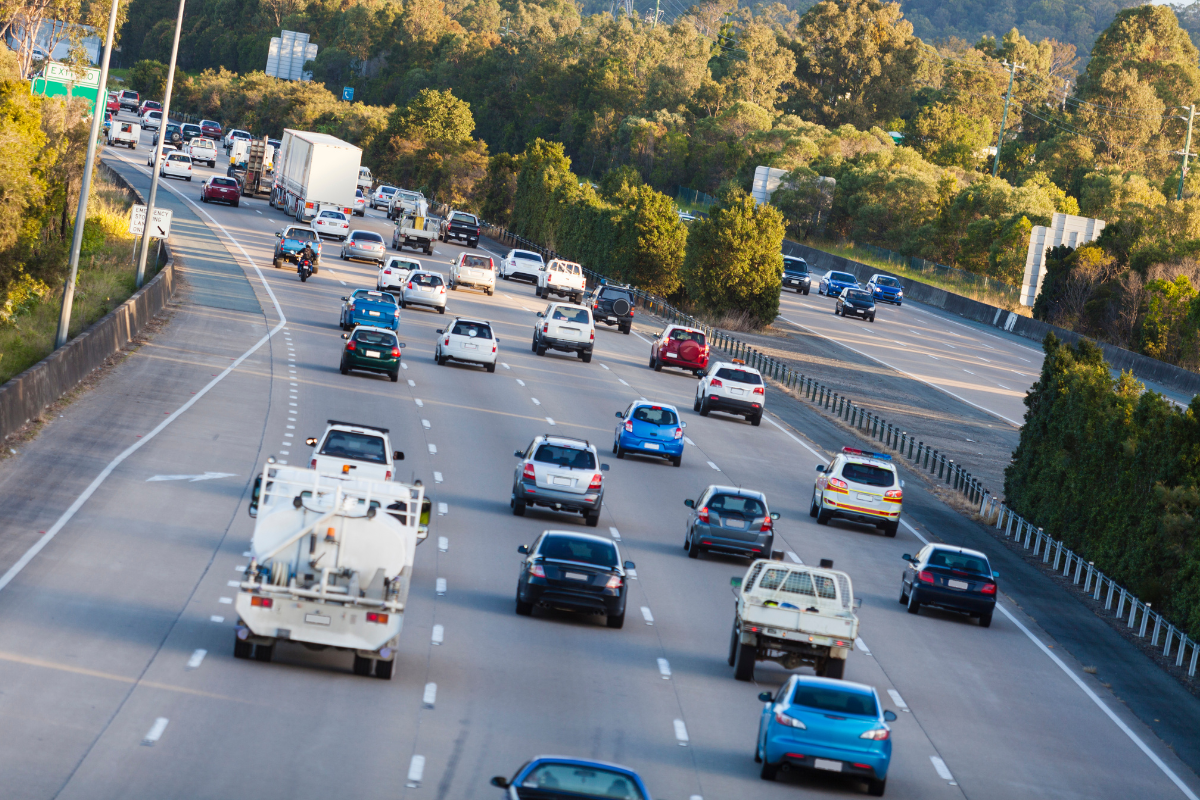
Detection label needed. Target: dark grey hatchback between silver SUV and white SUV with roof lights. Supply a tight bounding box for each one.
[683,486,779,559]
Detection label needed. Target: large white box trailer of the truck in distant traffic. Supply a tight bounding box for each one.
[271,128,362,223]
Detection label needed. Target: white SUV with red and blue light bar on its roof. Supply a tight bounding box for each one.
[809,447,904,536]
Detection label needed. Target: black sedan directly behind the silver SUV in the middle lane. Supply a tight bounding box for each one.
[517,530,634,627]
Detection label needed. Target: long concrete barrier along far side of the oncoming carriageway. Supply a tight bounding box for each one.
[784,240,1200,395]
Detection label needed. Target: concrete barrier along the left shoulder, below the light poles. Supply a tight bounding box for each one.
[0,163,176,441]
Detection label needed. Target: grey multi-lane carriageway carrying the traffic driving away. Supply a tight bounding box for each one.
[0,122,1200,800]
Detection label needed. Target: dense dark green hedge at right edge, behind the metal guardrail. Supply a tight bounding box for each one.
[1004,335,1200,637]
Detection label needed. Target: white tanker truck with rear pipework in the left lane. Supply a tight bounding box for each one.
[234,459,428,680]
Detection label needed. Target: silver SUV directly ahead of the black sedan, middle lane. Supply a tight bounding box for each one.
[509,434,608,528]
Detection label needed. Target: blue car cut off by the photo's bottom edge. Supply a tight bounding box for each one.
[492,756,650,800]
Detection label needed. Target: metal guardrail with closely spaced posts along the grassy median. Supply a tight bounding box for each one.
[482,222,1200,678]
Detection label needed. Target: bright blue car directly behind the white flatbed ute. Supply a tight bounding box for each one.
[755,675,896,798]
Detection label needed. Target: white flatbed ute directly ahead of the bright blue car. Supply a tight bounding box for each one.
[730,559,858,680]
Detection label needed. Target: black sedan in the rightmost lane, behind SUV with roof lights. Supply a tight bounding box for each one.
[900,545,1000,627]
